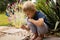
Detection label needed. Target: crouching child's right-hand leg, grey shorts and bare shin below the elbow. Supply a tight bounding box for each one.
[37,23,48,40]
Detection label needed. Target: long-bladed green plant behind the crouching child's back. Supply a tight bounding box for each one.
[36,0,60,28]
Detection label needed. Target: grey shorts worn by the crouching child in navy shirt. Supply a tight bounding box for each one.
[27,21,48,34]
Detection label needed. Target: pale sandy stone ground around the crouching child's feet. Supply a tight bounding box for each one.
[0,26,60,40]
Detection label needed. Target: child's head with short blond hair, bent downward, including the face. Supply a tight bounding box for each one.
[22,1,36,18]
